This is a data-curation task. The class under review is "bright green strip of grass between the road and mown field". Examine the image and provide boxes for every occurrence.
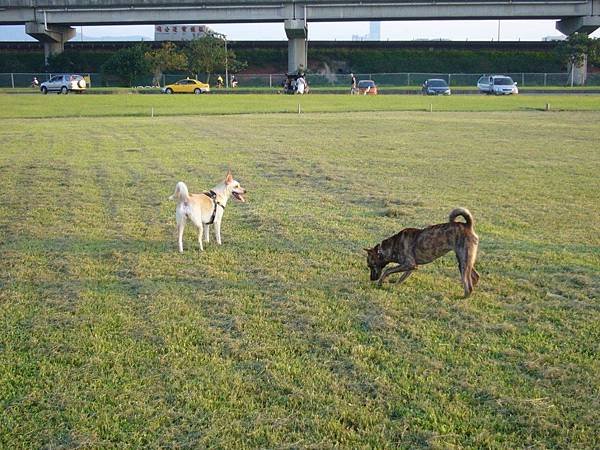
[0,94,600,118]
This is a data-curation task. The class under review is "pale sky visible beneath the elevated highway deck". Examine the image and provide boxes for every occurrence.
[0,20,600,41]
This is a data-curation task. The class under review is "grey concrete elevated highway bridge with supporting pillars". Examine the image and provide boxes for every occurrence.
[0,0,600,72]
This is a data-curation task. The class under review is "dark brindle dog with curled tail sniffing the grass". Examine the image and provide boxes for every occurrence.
[365,208,479,297]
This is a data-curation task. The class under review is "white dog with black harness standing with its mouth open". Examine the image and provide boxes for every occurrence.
[169,171,246,253]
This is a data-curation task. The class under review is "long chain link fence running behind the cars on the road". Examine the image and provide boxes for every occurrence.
[0,73,600,89]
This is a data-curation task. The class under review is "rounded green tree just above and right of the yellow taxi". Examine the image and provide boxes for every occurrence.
[187,35,247,83]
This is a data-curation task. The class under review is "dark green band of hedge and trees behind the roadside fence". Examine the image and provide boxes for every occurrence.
[0,33,600,81]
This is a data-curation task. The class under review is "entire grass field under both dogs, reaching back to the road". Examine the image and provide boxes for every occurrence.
[0,96,600,449]
